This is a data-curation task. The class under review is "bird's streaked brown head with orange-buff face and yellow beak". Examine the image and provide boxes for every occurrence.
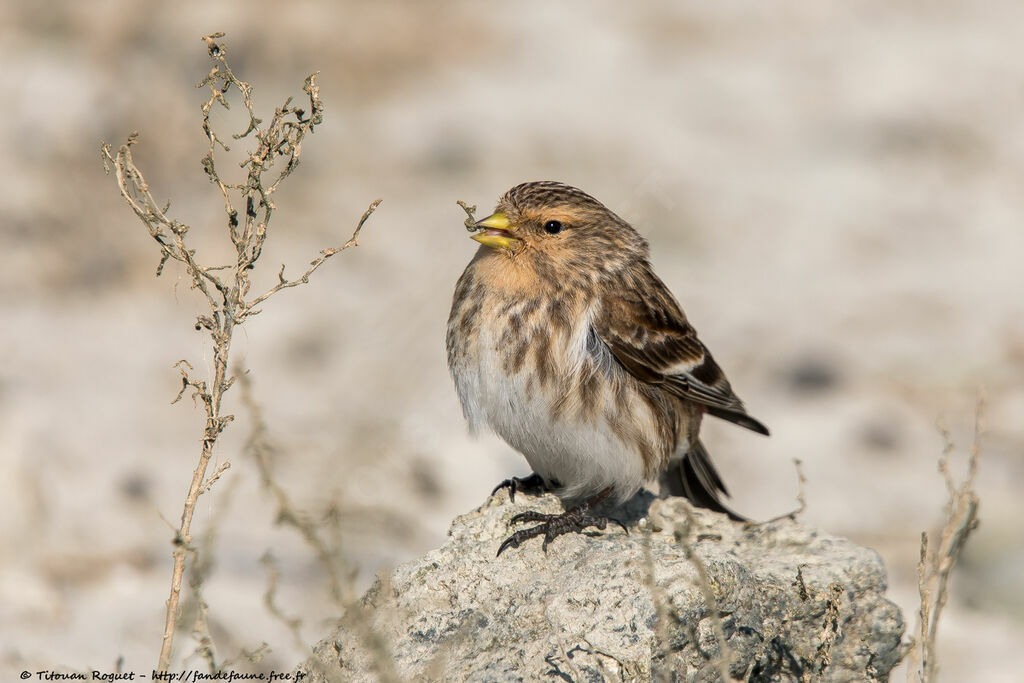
[470,181,647,279]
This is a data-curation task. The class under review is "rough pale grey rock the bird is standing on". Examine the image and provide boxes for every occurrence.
[302,493,904,681]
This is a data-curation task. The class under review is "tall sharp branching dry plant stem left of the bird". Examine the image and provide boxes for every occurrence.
[100,33,380,671]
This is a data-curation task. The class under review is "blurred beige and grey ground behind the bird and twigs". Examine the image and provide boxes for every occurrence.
[0,0,1024,681]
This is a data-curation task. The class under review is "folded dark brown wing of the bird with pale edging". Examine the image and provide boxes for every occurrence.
[594,268,768,434]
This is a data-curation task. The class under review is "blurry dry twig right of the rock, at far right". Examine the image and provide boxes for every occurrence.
[907,391,985,683]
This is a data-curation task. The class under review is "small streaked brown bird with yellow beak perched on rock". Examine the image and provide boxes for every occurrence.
[446,181,768,554]
